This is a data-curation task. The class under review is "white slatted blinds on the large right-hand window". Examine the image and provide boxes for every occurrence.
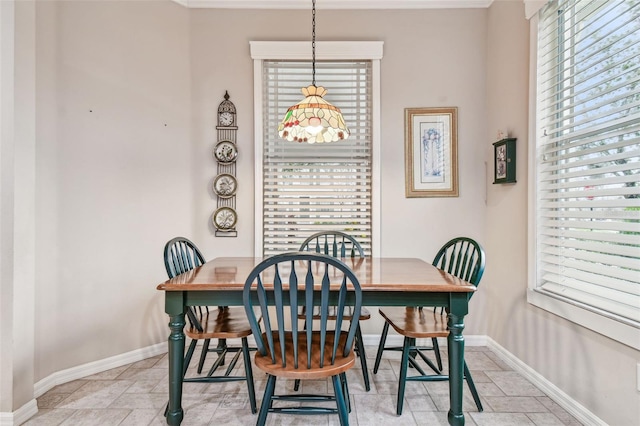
[536,0,640,327]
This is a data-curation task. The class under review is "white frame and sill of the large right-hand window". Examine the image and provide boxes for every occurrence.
[527,9,640,350]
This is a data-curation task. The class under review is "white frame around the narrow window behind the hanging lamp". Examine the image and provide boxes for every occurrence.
[249,41,383,257]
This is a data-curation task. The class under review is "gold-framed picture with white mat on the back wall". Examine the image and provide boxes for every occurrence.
[404,107,458,198]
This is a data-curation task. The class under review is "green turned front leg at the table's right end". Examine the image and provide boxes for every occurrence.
[447,294,468,426]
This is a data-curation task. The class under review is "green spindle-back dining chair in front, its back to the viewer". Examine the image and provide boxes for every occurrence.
[243,252,362,426]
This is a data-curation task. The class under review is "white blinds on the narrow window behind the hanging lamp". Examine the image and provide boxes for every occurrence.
[262,60,372,255]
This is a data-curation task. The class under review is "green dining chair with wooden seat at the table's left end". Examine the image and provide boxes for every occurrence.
[164,237,257,413]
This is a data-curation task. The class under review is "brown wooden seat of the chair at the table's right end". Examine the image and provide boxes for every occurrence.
[378,307,449,339]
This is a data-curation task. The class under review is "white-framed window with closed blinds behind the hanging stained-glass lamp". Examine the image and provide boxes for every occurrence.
[251,42,382,256]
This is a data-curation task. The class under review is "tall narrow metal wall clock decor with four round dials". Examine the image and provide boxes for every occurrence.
[211,91,238,237]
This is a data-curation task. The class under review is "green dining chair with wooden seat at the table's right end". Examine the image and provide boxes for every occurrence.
[373,237,485,415]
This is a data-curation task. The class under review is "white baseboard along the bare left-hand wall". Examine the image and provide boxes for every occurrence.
[33,343,167,398]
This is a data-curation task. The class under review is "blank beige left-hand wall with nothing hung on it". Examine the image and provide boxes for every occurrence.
[35,1,193,380]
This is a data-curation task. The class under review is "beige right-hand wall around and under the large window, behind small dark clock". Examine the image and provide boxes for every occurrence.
[483,1,640,426]
